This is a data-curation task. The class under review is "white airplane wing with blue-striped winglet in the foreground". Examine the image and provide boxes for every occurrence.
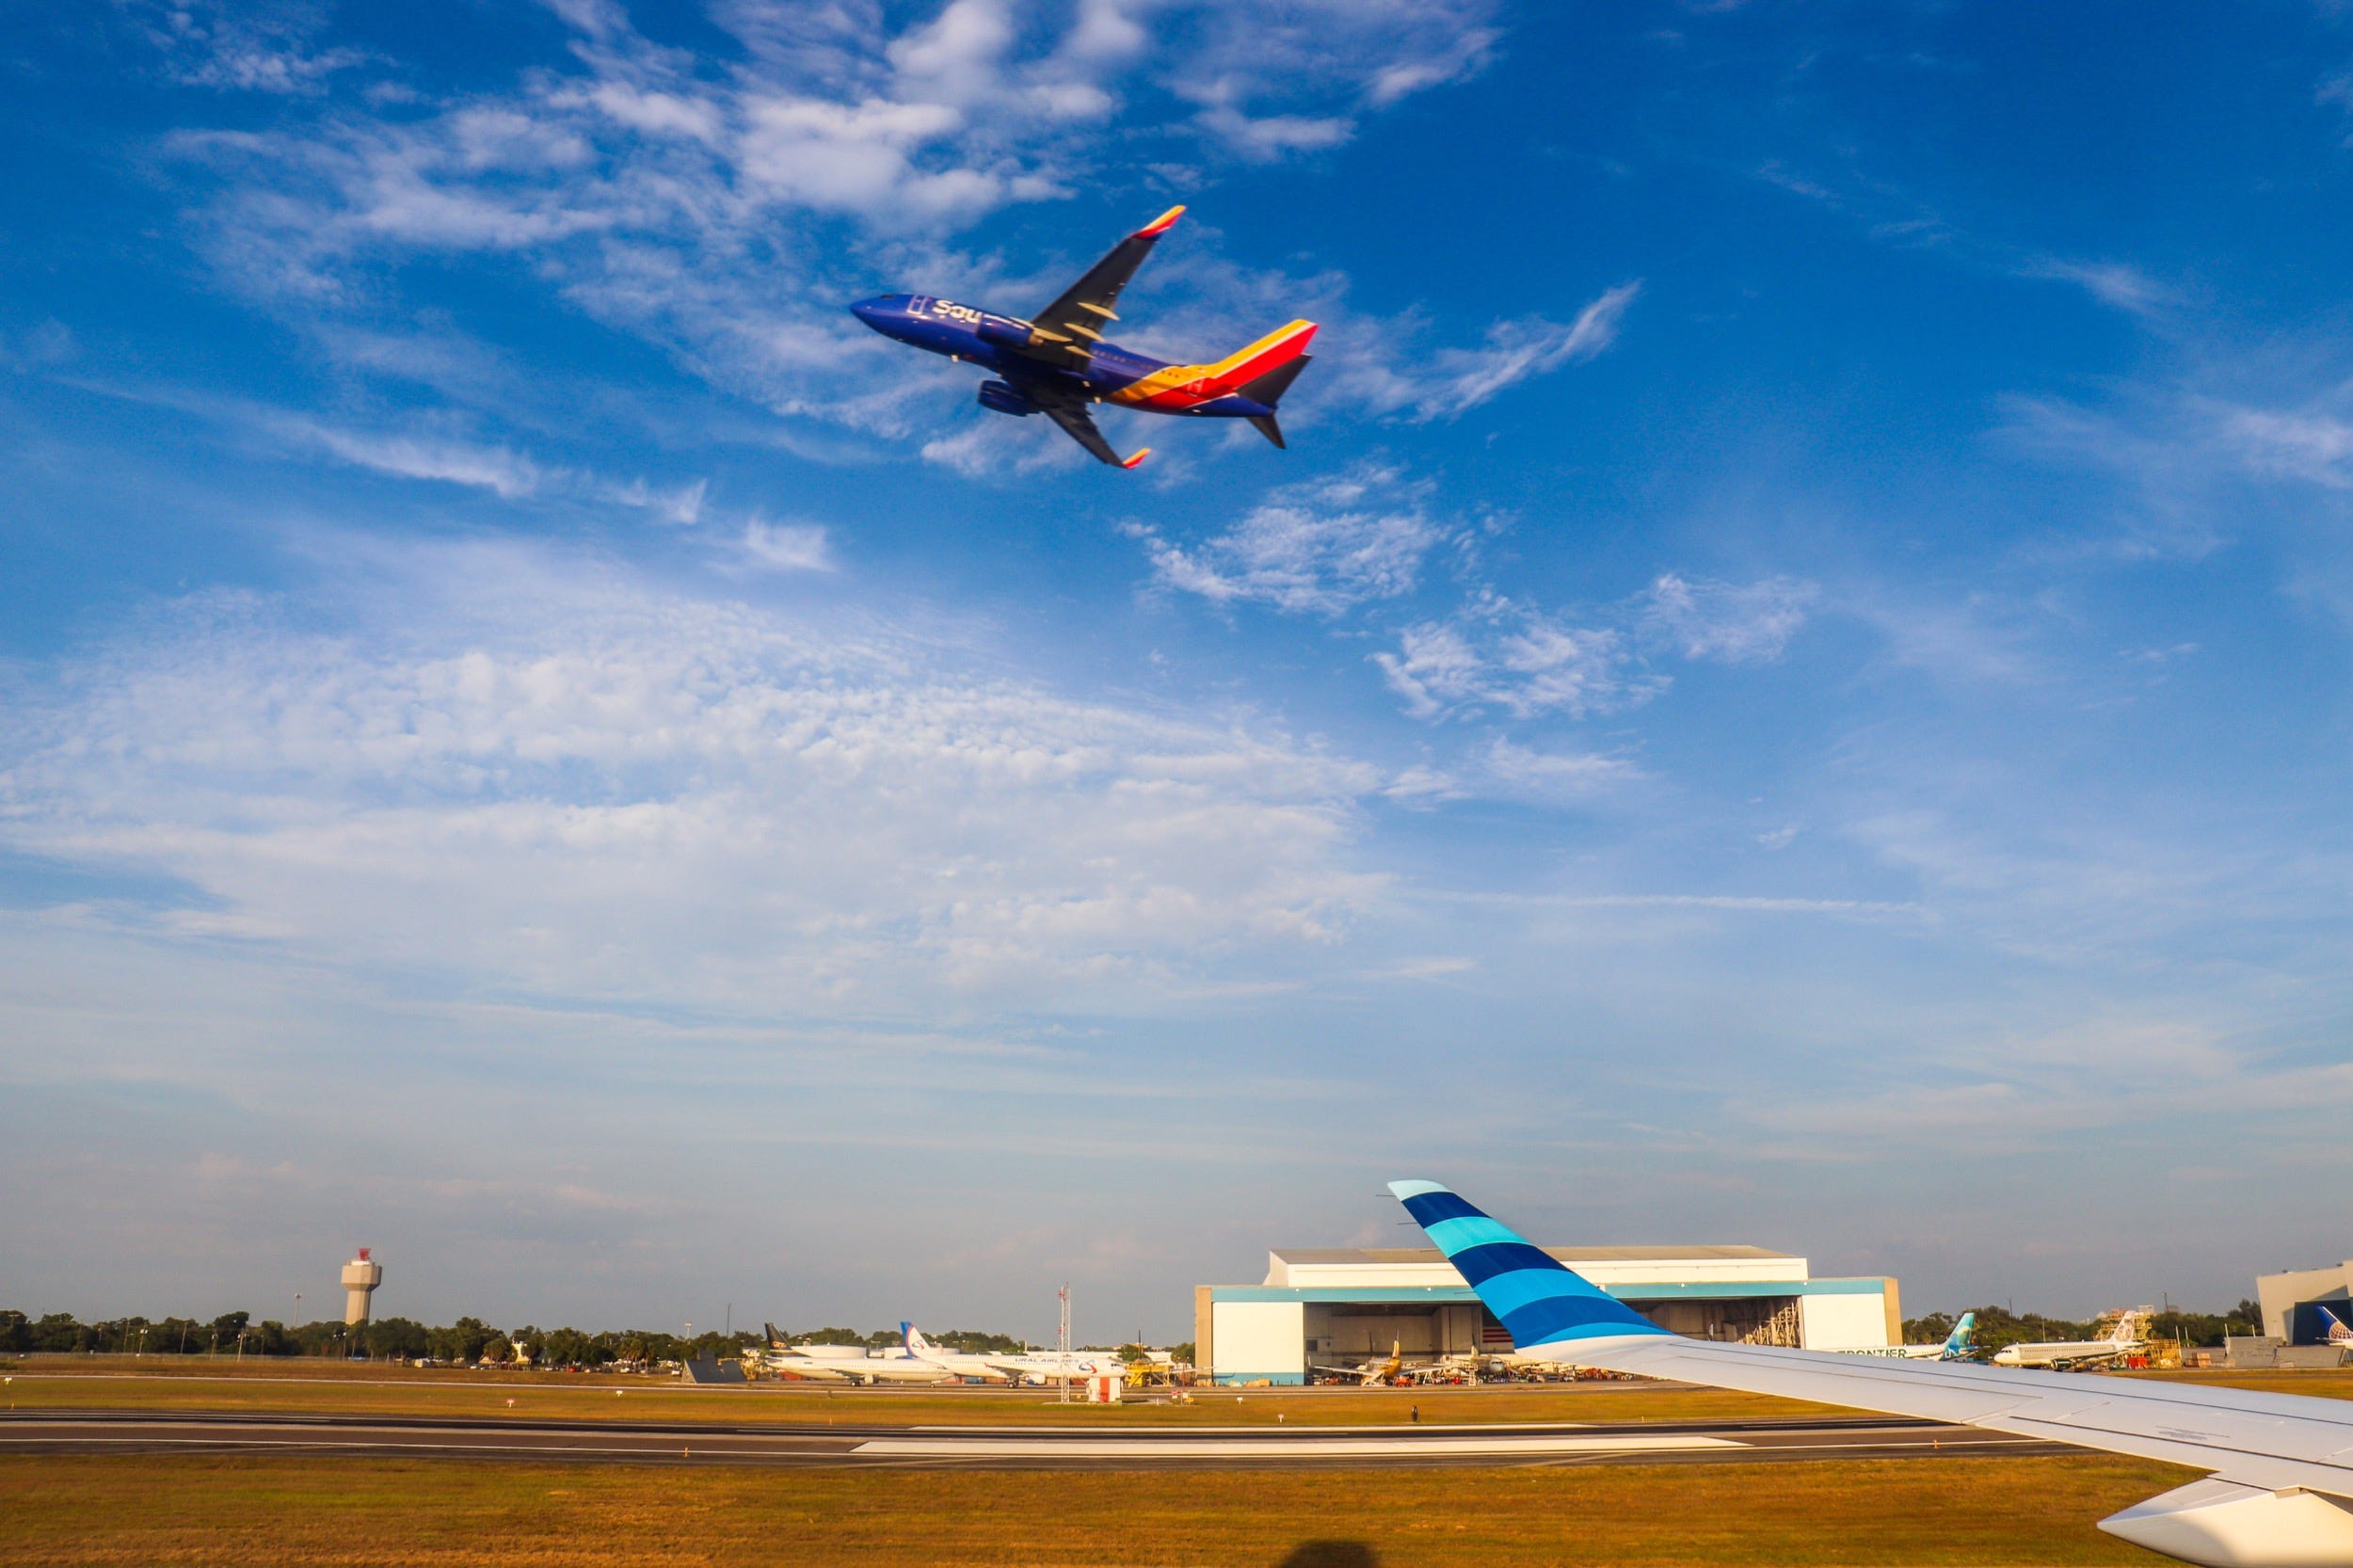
[1388,1182,2353,1568]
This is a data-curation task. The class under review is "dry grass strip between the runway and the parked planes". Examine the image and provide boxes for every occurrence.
[8,1358,1835,1427]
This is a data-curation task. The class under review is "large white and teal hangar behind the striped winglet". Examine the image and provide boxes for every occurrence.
[1193,1245,1904,1384]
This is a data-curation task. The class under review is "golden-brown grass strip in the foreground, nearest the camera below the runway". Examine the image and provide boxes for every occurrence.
[0,1455,2191,1568]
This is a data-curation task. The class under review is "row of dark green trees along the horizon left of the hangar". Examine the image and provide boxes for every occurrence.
[0,1311,1049,1366]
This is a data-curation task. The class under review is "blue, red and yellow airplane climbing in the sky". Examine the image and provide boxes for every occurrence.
[850,207,1316,469]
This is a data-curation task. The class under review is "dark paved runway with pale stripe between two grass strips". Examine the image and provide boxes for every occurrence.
[0,1410,2071,1469]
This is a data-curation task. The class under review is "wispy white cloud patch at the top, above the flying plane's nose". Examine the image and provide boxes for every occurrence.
[156,0,1506,452]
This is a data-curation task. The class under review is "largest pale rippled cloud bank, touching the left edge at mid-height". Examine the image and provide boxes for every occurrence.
[0,530,1384,1015]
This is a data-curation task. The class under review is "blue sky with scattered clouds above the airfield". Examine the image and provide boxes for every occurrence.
[0,0,2353,1337]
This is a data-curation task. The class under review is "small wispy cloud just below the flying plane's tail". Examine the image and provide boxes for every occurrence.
[1134,464,1445,615]
